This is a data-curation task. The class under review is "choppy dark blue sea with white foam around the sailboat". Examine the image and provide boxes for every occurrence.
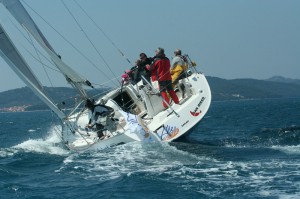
[0,99,300,199]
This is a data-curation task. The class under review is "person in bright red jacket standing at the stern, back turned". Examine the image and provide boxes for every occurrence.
[150,48,179,108]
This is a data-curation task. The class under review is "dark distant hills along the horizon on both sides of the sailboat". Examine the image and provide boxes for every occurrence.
[0,76,300,111]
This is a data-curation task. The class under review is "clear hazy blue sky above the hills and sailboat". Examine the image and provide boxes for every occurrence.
[0,0,300,92]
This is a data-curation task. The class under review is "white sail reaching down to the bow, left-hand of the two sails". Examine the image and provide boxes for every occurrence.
[0,24,65,119]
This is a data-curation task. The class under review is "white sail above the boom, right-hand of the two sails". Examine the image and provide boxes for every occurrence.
[0,0,89,96]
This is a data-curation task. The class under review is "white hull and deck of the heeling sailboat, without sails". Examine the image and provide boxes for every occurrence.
[63,73,211,151]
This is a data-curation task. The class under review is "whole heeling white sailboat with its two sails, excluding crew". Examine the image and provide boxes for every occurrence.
[0,0,211,151]
